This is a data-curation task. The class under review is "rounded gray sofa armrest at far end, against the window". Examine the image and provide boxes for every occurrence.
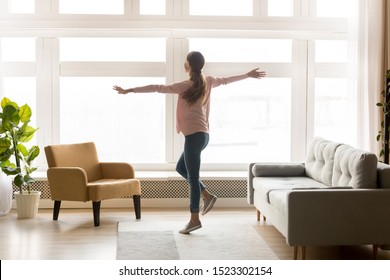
[251,162,305,177]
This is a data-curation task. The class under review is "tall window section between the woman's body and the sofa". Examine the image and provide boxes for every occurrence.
[190,38,292,163]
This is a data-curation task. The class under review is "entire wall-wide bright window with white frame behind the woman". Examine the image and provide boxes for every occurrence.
[0,0,358,170]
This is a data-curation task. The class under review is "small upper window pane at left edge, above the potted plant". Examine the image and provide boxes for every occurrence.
[0,38,36,61]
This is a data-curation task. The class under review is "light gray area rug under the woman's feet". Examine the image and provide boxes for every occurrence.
[117,221,278,260]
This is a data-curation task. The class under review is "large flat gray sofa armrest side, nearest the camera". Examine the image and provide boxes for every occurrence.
[286,189,390,246]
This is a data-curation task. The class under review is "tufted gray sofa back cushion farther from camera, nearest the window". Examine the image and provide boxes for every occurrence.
[305,137,341,186]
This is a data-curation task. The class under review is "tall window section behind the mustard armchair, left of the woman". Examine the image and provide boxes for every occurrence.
[59,38,166,163]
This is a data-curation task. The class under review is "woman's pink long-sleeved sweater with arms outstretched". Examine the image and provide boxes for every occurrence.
[133,74,248,136]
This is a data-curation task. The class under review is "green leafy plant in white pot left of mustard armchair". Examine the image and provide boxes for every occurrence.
[0,97,41,218]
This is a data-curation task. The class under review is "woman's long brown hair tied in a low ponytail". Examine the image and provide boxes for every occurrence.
[183,51,206,105]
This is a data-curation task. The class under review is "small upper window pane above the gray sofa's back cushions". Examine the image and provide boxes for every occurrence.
[315,40,348,63]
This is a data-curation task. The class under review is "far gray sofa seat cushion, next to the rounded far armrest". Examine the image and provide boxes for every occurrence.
[253,177,328,203]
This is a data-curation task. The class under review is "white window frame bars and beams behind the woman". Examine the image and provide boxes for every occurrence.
[0,0,354,170]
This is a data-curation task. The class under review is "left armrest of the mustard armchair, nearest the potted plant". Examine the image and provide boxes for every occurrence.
[47,167,89,201]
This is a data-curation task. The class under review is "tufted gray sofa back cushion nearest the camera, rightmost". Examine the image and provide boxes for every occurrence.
[332,145,378,189]
